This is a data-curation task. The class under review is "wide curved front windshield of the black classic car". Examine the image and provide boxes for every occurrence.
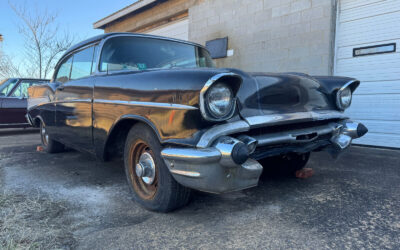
[100,36,214,72]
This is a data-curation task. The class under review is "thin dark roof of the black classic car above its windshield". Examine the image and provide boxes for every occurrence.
[61,32,208,58]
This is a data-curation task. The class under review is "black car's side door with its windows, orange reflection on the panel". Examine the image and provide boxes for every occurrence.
[55,46,95,152]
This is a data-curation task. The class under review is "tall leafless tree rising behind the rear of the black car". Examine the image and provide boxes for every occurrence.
[8,1,74,78]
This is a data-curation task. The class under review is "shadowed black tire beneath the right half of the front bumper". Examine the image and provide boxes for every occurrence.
[260,153,310,178]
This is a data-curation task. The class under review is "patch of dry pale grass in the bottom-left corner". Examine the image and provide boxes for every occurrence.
[0,192,76,249]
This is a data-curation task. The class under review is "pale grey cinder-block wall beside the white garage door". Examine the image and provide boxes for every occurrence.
[189,0,335,74]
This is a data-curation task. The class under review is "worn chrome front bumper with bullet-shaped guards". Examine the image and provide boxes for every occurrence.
[161,120,368,193]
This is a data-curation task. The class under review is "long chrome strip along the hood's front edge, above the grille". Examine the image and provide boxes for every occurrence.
[244,111,348,128]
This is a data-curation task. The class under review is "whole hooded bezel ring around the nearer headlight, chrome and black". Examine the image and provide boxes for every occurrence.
[199,73,242,122]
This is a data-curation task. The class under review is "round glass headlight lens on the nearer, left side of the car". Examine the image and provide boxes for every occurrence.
[207,83,234,118]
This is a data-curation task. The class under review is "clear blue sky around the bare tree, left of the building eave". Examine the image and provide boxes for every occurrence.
[0,0,135,72]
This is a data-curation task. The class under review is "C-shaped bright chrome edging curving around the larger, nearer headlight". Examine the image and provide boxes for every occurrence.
[200,72,241,121]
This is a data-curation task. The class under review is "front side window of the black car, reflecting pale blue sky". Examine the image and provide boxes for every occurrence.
[70,46,94,80]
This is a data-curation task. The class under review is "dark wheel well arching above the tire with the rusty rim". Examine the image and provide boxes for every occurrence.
[104,119,159,160]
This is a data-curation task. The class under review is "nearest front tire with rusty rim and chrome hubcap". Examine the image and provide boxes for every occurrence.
[124,124,191,212]
